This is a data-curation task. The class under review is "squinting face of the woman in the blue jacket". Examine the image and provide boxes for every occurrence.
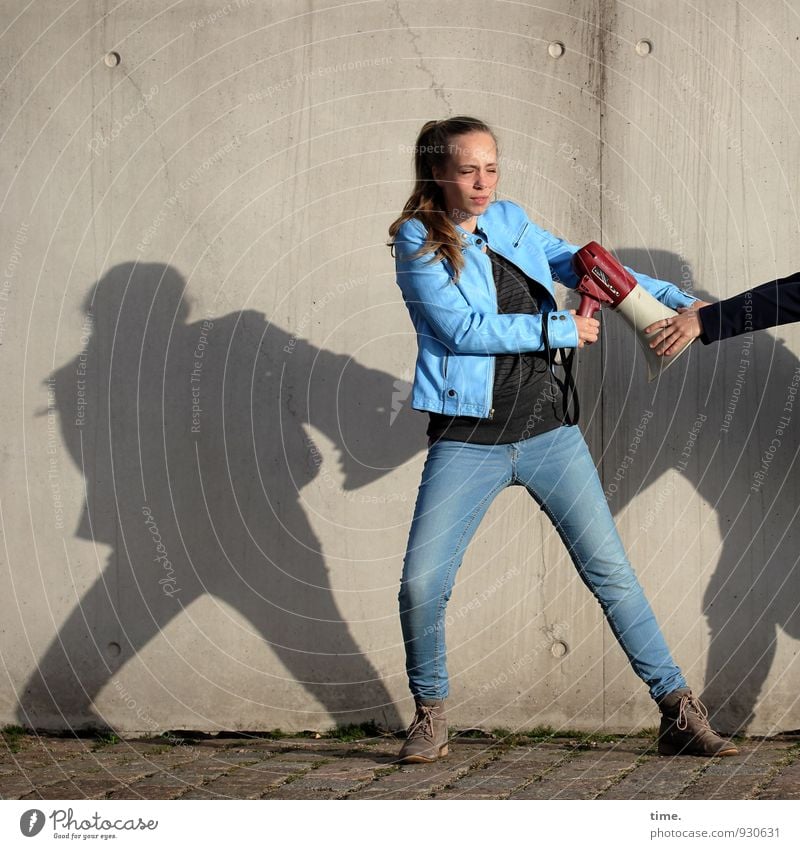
[433,131,498,230]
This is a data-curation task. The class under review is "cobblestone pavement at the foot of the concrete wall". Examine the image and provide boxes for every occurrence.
[0,734,800,800]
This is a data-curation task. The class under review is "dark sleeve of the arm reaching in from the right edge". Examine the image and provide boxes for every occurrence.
[699,271,800,345]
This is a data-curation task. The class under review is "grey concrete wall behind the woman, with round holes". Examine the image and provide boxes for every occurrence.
[0,0,800,733]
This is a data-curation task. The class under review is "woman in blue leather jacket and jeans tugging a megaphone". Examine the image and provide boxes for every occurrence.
[389,117,737,763]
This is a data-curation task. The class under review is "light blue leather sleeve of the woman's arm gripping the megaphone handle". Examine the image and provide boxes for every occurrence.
[394,222,578,354]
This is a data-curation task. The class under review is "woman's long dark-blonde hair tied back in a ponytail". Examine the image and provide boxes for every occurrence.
[387,115,497,280]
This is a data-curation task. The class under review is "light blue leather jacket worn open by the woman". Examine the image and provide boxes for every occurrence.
[394,200,695,418]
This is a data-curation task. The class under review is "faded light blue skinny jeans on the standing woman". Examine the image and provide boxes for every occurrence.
[399,426,686,701]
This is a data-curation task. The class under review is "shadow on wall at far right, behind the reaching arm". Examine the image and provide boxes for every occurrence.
[604,250,800,732]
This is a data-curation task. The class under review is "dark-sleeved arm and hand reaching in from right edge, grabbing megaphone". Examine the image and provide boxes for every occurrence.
[645,271,800,356]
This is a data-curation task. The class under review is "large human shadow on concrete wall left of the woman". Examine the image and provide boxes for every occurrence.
[19,263,424,729]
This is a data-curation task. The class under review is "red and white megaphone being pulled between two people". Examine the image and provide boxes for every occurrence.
[572,242,693,381]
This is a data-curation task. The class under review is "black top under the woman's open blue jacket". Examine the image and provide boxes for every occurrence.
[428,246,563,445]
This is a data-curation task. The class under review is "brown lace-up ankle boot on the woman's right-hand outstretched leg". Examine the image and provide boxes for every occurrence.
[658,687,739,757]
